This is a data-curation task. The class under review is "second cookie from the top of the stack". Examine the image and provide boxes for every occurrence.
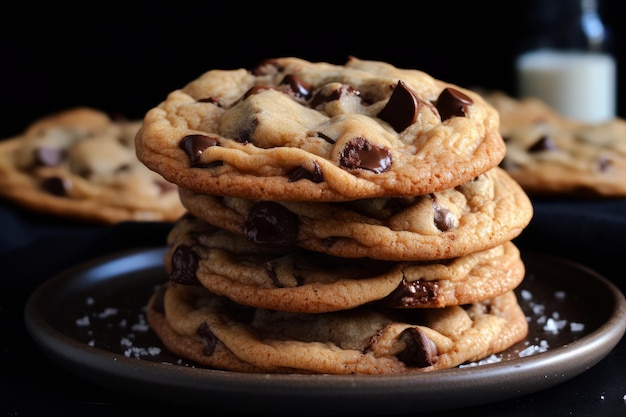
[179,167,533,260]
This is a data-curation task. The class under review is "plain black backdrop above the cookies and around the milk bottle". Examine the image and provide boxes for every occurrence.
[0,0,626,138]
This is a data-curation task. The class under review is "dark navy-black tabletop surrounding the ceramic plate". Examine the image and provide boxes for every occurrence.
[0,199,626,417]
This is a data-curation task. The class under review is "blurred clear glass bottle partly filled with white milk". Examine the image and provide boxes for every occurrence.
[515,0,617,123]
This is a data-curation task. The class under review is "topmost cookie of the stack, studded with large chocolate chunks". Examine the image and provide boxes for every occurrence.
[136,57,506,201]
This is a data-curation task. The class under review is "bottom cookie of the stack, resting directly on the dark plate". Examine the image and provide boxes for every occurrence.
[147,282,528,374]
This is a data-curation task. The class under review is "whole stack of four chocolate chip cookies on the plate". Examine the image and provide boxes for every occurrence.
[136,57,533,374]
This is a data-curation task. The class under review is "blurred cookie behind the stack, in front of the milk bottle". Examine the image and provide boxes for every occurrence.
[484,92,626,197]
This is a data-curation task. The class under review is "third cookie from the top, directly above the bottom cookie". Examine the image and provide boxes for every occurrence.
[165,215,525,313]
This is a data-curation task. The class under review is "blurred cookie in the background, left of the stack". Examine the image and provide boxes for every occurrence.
[0,107,185,224]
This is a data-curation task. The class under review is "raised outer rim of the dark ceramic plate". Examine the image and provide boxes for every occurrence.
[24,247,626,415]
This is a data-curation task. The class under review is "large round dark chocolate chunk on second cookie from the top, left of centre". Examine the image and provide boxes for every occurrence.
[244,201,298,246]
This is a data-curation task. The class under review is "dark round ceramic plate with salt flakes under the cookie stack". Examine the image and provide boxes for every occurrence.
[25,248,626,415]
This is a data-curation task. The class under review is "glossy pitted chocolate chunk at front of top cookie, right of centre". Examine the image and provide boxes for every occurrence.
[339,137,393,174]
